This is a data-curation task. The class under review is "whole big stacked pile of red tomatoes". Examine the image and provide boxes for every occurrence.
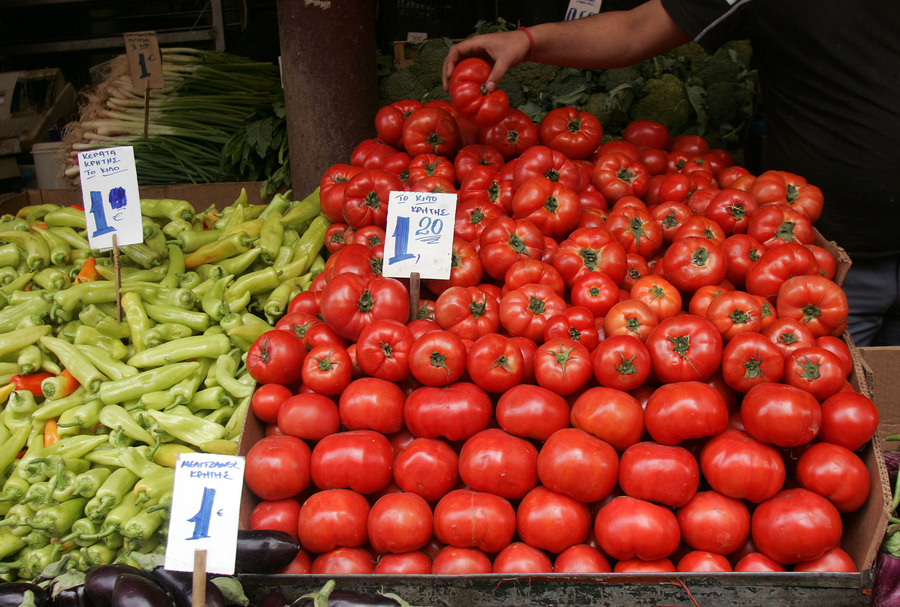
[239,60,878,574]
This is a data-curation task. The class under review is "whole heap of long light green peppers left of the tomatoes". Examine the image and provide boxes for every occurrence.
[0,192,330,581]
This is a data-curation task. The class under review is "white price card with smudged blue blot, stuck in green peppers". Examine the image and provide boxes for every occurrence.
[78,146,144,251]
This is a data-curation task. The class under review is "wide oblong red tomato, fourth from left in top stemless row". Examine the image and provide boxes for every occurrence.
[403,382,493,441]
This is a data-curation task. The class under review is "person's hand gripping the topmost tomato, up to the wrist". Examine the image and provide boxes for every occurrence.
[441,30,531,92]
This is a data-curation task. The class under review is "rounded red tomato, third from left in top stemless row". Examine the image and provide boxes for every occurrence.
[335,377,406,435]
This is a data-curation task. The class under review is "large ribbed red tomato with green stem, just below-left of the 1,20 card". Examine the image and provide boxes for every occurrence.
[321,276,409,340]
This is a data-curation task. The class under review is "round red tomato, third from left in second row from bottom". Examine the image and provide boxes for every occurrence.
[367,493,432,554]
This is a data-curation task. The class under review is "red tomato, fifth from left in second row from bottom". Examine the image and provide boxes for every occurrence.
[516,485,591,554]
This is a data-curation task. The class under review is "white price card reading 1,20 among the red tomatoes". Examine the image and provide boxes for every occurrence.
[382,192,456,280]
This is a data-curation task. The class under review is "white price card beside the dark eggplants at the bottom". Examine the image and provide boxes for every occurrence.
[165,453,244,575]
